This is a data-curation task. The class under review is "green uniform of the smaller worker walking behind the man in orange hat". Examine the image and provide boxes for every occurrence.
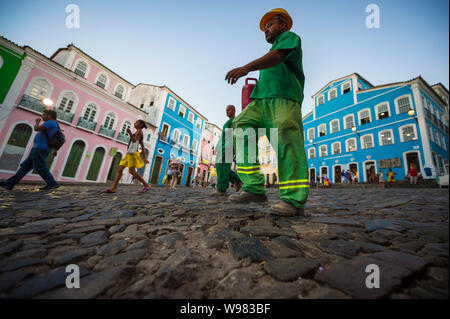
[216,119,238,192]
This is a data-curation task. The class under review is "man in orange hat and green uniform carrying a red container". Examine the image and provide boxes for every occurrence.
[225,9,309,216]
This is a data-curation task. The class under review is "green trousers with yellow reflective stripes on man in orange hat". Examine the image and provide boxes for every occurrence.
[232,98,309,207]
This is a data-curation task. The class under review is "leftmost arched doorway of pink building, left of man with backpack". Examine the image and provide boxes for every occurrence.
[0,124,33,171]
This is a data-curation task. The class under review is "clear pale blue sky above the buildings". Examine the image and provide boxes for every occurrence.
[0,0,449,127]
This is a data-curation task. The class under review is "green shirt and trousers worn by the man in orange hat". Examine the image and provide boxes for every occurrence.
[232,31,309,208]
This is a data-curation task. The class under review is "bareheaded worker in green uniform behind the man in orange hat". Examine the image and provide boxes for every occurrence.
[213,105,242,195]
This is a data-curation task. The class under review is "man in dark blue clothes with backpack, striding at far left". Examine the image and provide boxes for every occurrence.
[0,110,59,190]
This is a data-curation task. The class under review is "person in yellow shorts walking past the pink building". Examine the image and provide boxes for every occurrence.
[105,120,150,193]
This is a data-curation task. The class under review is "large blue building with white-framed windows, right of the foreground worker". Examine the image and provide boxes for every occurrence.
[303,73,449,183]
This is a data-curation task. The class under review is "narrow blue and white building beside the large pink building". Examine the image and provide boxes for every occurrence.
[149,87,207,185]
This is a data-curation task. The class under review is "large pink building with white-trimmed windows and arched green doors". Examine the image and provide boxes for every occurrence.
[0,38,156,182]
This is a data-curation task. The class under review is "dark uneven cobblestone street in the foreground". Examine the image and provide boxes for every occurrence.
[0,185,449,298]
